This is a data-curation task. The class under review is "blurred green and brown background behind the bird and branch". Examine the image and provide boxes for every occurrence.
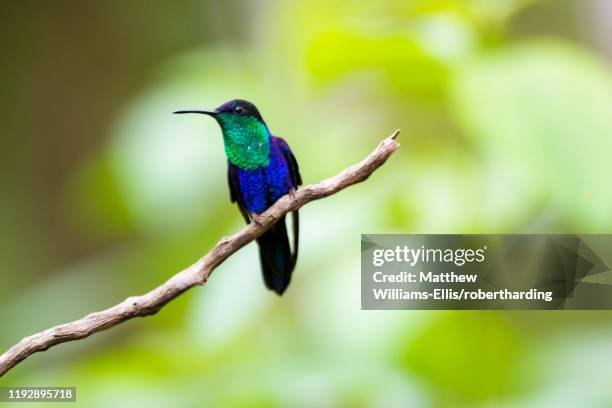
[0,0,612,407]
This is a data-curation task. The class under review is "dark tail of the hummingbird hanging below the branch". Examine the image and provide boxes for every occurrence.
[257,212,297,295]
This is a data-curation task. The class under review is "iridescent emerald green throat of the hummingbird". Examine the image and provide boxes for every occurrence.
[217,113,270,170]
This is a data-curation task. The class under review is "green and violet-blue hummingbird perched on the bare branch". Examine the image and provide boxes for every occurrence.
[174,99,302,295]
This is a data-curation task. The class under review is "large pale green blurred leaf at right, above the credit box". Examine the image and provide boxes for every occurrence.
[452,41,612,230]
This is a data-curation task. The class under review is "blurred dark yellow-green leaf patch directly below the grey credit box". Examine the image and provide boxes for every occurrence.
[402,312,519,401]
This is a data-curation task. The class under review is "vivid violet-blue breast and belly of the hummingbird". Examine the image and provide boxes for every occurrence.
[238,143,293,214]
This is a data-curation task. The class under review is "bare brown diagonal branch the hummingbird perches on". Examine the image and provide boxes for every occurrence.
[0,130,399,377]
